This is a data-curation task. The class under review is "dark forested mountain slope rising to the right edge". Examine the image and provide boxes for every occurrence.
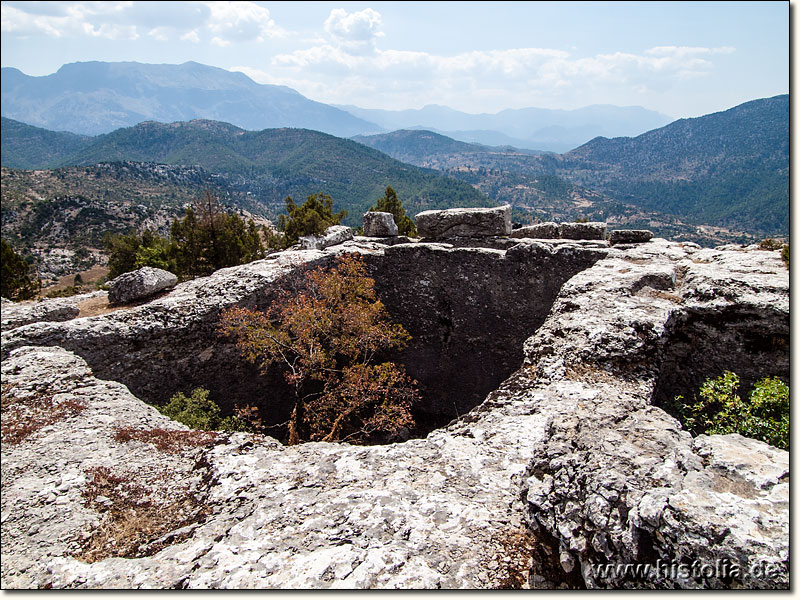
[543,95,789,235]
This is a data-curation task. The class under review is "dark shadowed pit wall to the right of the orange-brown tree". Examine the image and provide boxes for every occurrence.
[369,242,604,424]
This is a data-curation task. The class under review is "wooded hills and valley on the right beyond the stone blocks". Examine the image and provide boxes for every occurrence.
[355,95,789,241]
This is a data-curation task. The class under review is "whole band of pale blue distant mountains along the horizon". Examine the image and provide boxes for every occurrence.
[1,62,672,152]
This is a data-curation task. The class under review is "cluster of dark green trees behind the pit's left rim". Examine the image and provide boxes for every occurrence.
[106,192,266,279]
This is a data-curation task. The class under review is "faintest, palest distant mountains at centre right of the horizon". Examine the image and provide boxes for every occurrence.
[339,104,672,152]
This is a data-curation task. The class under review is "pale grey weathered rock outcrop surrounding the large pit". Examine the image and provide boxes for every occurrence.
[0,240,789,589]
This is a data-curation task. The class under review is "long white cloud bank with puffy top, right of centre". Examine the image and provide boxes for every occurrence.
[260,29,734,110]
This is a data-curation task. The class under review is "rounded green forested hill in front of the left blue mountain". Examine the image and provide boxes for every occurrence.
[2,120,493,225]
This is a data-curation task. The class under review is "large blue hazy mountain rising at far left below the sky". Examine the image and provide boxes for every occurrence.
[0,62,380,136]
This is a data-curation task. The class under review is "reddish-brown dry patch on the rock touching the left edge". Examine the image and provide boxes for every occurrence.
[0,386,87,445]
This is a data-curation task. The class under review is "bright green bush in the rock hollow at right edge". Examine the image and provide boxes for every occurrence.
[675,371,789,450]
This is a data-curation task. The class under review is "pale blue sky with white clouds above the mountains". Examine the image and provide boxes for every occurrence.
[0,0,795,118]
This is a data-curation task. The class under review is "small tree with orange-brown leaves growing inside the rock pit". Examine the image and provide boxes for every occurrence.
[219,256,418,444]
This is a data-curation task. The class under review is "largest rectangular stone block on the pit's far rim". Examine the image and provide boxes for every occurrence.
[414,205,511,240]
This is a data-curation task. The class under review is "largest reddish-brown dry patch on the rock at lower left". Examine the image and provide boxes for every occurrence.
[74,467,208,563]
